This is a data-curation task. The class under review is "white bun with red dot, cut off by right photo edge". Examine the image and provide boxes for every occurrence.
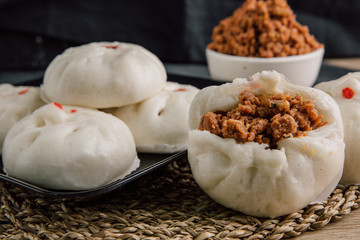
[315,72,360,184]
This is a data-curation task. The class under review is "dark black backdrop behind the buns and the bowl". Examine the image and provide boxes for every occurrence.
[0,0,360,71]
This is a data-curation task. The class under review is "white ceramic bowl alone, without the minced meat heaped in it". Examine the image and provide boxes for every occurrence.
[206,48,324,87]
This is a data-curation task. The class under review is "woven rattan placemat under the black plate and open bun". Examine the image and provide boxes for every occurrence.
[0,158,360,240]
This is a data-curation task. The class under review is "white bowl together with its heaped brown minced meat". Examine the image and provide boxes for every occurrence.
[206,0,324,86]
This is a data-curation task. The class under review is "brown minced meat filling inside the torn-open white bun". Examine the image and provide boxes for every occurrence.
[198,90,327,148]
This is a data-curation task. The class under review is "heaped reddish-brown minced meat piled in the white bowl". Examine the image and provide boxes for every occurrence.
[208,0,324,58]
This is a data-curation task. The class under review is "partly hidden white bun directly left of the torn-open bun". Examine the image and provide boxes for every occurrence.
[111,82,199,153]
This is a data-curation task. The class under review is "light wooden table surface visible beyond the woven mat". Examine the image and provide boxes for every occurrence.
[292,58,360,240]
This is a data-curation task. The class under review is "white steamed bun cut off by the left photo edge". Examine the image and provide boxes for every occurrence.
[0,83,45,153]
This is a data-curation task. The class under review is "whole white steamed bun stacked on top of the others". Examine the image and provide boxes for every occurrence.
[41,42,167,108]
